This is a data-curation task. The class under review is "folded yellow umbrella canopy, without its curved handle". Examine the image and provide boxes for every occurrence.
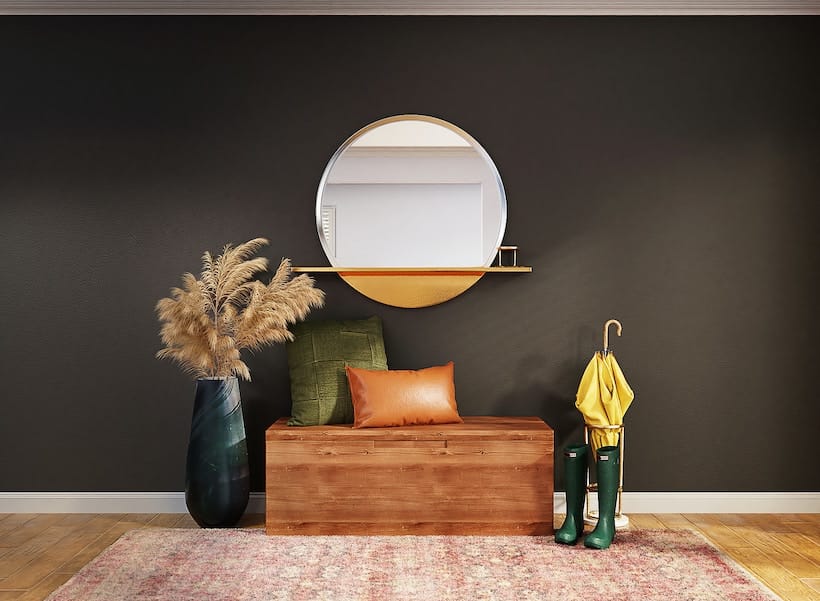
[575,351,635,453]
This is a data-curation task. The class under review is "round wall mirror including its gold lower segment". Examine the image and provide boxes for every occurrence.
[316,115,507,307]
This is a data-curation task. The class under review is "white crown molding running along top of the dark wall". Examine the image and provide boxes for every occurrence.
[0,0,820,16]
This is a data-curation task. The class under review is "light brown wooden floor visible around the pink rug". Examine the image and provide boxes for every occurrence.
[0,513,820,601]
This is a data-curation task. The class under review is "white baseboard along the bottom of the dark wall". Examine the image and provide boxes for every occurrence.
[0,492,820,514]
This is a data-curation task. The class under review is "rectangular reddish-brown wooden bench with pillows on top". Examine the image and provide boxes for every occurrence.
[265,417,554,535]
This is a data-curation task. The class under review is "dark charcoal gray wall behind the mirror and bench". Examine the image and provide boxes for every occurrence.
[0,17,820,491]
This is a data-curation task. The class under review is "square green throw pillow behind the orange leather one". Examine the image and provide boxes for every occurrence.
[286,317,387,426]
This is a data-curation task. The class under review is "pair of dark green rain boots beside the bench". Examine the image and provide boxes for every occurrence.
[555,444,621,549]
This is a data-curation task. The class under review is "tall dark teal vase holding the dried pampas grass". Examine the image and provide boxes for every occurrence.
[185,377,250,528]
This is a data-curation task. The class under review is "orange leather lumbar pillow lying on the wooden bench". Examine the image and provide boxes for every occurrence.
[345,361,463,428]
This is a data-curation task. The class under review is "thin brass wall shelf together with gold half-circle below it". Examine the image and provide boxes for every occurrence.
[293,266,532,309]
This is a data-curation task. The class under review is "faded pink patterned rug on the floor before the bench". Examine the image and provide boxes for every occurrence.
[48,528,779,601]
